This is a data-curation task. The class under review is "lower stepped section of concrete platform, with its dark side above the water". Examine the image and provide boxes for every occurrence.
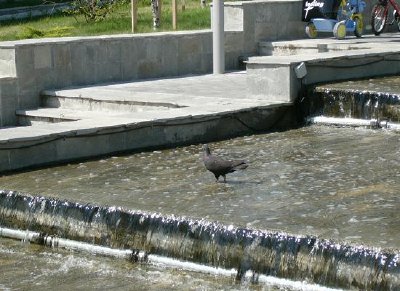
[0,71,293,172]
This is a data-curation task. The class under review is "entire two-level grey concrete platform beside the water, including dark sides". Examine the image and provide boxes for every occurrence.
[0,34,400,176]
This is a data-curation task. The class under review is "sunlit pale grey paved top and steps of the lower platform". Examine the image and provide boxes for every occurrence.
[0,71,286,144]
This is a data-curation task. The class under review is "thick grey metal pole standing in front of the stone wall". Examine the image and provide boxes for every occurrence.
[212,0,225,74]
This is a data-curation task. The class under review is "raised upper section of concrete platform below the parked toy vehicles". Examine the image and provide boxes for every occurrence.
[247,34,400,101]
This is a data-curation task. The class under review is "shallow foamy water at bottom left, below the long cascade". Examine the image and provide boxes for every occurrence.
[0,238,255,290]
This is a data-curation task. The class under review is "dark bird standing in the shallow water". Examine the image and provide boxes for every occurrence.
[203,144,248,182]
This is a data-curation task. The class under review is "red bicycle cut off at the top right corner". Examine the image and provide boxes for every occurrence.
[371,0,400,35]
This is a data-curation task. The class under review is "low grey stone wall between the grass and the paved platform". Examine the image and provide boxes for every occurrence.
[0,30,247,126]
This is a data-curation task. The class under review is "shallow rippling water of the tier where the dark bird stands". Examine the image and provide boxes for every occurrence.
[0,126,400,249]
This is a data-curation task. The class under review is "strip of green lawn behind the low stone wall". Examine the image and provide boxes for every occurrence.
[0,0,211,41]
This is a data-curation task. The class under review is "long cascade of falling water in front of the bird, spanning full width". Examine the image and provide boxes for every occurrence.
[0,190,400,290]
